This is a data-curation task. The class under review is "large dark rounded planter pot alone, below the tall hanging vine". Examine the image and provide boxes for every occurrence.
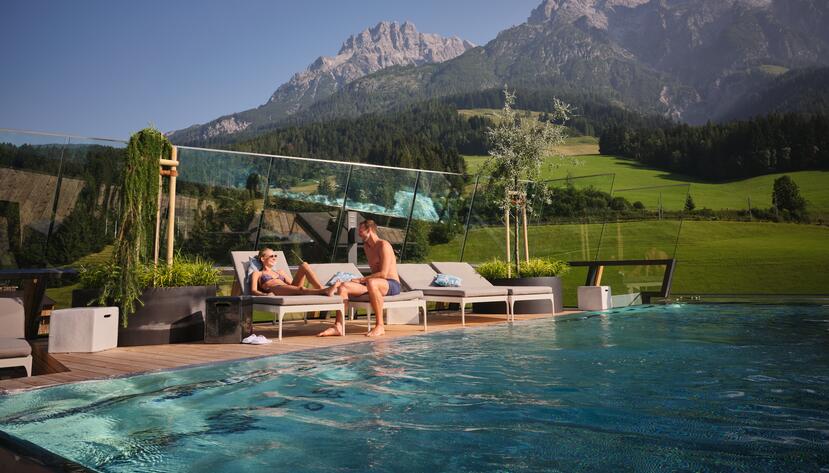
[72,286,216,347]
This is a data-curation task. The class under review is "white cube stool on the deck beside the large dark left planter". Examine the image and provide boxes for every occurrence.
[49,307,118,353]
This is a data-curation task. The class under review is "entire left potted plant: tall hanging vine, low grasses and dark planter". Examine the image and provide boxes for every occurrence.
[73,128,218,345]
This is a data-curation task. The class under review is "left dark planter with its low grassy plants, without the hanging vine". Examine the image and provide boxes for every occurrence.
[72,257,220,346]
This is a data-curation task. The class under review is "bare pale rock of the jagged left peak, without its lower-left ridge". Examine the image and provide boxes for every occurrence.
[269,21,475,113]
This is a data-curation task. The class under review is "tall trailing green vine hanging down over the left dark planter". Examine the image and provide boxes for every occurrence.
[99,128,173,327]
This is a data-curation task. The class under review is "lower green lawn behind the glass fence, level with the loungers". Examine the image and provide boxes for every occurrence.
[429,221,829,303]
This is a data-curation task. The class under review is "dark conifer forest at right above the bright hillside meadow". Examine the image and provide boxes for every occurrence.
[599,113,829,180]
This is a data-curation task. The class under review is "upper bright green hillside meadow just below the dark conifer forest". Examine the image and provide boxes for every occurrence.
[466,137,829,221]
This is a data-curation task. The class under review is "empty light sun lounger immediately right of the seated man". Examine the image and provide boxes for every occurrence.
[397,264,510,325]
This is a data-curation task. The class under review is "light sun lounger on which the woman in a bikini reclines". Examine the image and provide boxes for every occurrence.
[230,251,345,340]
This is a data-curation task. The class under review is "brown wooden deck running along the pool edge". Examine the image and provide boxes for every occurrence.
[0,311,572,393]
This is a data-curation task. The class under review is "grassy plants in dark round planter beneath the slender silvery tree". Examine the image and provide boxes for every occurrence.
[474,258,570,314]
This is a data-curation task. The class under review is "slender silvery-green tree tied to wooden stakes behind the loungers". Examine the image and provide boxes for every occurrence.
[483,87,572,275]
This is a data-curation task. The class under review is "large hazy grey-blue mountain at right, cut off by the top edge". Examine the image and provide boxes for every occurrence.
[296,0,829,123]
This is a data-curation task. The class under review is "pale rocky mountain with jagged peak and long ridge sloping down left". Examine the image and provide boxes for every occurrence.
[170,22,474,144]
